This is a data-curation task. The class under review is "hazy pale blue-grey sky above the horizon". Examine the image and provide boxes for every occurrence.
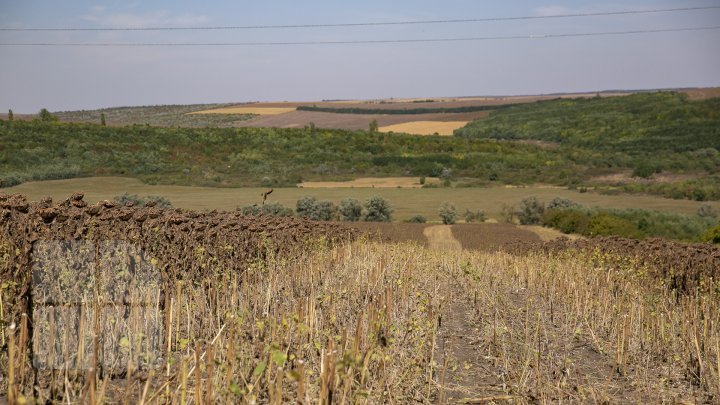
[0,0,720,113]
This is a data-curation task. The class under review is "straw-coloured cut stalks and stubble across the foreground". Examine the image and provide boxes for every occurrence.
[3,238,720,404]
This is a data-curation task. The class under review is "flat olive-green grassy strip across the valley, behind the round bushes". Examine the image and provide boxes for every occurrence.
[0,177,720,221]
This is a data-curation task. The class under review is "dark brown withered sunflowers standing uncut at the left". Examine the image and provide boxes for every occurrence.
[0,193,359,315]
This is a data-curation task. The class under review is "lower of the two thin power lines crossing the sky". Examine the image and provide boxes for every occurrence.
[0,25,720,47]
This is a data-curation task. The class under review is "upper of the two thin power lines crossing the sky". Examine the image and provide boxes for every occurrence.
[0,6,720,31]
